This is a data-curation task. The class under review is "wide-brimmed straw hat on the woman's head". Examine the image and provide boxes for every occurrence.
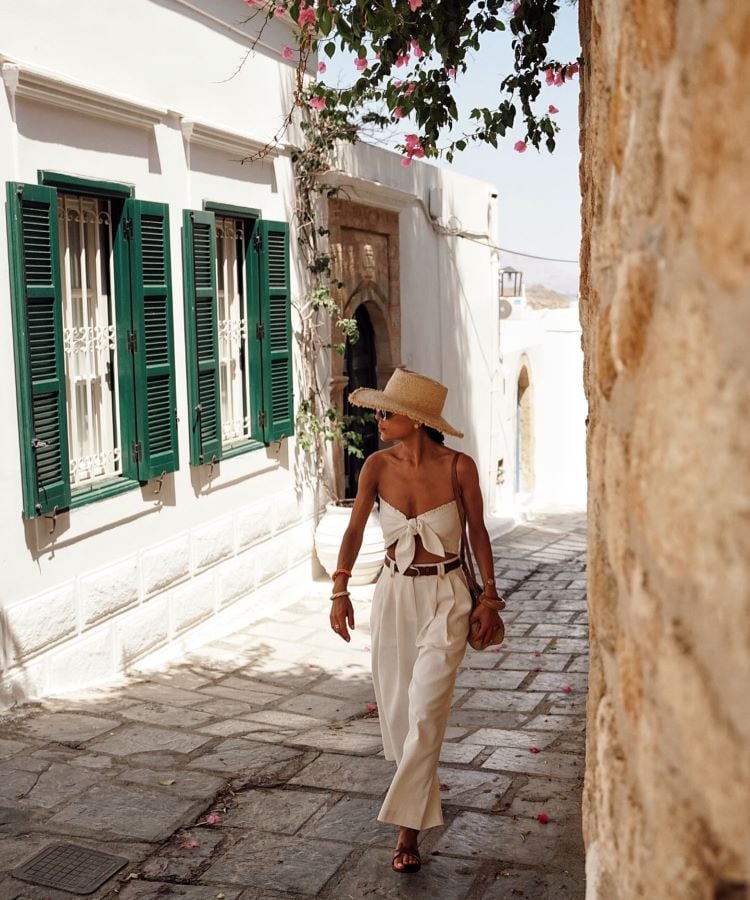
[349,367,464,437]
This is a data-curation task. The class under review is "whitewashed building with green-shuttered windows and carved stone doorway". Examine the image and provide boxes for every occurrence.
[0,0,516,704]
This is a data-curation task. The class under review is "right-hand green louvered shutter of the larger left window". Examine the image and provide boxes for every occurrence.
[125,200,178,481]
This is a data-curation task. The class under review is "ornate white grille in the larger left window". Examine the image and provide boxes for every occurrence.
[57,194,121,488]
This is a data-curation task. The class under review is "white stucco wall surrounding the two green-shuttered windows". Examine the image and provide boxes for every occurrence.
[0,0,312,703]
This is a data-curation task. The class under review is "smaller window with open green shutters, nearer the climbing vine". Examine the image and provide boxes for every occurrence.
[183,209,293,466]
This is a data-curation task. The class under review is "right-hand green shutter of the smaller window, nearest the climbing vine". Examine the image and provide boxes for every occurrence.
[259,220,294,442]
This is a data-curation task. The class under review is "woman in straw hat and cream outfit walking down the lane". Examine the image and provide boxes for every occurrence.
[331,369,504,872]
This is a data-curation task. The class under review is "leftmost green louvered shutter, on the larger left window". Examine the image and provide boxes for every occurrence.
[7,183,70,518]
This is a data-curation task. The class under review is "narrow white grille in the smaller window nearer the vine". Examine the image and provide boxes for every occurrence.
[216,216,250,448]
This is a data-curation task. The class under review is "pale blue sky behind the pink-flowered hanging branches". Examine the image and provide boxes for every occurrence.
[324,4,580,294]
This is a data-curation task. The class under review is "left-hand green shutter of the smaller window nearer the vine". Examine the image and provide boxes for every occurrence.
[182,209,221,466]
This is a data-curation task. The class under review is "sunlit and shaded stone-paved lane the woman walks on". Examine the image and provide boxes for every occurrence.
[0,513,588,900]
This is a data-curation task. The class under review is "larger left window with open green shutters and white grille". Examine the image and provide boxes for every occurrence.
[7,179,177,518]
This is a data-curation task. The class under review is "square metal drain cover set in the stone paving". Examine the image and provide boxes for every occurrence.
[11,844,128,894]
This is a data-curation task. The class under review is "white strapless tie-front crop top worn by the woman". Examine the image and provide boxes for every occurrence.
[380,497,461,572]
